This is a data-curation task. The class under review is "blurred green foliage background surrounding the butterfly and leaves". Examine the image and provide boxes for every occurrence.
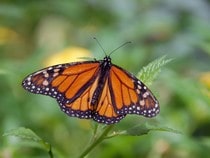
[0,0,210,158]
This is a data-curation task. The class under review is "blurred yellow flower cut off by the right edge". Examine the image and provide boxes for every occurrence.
[200,72,210,97]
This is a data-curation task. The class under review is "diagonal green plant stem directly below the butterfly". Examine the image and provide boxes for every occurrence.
[79,125,114,158]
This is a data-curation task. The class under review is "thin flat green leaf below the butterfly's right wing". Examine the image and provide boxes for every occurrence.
[121,124,181,136]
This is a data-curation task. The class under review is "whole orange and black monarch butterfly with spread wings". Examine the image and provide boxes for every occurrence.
[22,41,159,124]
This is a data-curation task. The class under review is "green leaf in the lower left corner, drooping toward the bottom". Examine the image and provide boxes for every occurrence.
[3,127,51,153]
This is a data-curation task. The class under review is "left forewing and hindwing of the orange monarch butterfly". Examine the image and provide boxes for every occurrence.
[22,61,99,118]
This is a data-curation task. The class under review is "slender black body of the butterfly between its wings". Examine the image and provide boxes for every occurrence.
[91,56,112,109]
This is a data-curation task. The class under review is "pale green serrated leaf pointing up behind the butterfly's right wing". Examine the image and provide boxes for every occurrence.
[137,55,172,85]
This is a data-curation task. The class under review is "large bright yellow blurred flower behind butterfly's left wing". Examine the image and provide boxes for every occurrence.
[45,47,92,66]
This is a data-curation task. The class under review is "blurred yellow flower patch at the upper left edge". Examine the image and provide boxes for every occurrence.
[0,27,18,44]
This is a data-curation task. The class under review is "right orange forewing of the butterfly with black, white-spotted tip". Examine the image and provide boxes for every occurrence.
[109,65,159,117]
